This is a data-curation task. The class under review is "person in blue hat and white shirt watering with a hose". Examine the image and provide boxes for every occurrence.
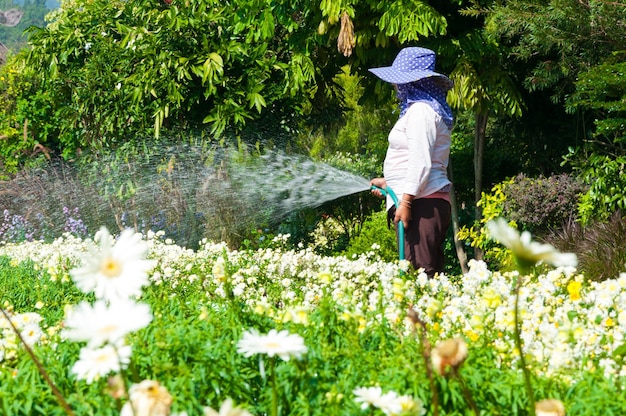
[370,47,454,277]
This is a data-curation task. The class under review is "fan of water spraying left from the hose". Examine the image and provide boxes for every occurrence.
[0,144,369,246]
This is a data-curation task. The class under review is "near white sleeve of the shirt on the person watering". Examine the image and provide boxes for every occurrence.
[404,102,437,196]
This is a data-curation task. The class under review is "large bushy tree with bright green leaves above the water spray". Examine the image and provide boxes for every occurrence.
[1,0,326,156]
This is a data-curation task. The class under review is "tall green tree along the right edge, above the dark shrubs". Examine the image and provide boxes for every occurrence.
[488,0,626,222]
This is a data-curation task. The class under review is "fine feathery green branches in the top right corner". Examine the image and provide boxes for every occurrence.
[487,0,626,101]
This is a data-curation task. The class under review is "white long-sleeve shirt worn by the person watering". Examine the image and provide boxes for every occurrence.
[383,102,451,209]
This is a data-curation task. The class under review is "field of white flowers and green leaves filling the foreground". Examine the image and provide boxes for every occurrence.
[0,229,626,416]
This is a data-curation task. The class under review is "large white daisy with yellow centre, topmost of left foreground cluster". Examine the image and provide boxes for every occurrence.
[70,227,156,300]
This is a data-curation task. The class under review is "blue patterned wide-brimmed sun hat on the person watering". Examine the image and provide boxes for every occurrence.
[370,47,454,90]
